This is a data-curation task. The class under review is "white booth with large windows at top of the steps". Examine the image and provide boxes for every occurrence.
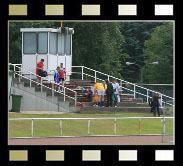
[20,27,74,81]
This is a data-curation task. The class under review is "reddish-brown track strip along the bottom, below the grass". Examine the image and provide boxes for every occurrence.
[8,136,173,145]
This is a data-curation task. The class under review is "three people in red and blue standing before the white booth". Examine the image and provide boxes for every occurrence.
[36,59,66,92]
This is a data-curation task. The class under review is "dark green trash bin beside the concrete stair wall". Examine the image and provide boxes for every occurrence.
[11,94,22,112]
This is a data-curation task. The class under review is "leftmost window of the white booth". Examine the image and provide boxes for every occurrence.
[23,32,37,54]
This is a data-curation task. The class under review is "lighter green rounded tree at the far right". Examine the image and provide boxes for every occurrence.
[143,22,173,84]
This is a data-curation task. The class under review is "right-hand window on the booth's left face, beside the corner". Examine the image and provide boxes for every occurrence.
[38,32,48,54]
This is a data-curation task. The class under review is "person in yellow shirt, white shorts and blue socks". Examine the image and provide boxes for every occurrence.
[94,82,105,107]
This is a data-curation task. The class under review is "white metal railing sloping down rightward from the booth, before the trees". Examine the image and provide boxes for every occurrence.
[72,66,174,106]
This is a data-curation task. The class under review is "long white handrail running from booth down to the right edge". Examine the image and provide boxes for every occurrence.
[72,66,174,106]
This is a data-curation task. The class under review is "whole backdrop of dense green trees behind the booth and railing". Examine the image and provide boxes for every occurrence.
[9,22,173,83]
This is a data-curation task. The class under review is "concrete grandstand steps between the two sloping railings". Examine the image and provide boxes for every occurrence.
[13,78,169,114]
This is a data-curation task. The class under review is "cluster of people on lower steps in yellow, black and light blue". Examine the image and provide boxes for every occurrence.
[93,80,119,107]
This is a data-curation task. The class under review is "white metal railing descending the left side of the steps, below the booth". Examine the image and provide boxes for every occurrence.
[10,64,77,106]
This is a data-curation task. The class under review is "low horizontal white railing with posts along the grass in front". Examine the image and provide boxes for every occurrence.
[9,117,174,142]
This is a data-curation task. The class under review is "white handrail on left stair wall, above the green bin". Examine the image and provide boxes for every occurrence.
[9,64,77,106]
